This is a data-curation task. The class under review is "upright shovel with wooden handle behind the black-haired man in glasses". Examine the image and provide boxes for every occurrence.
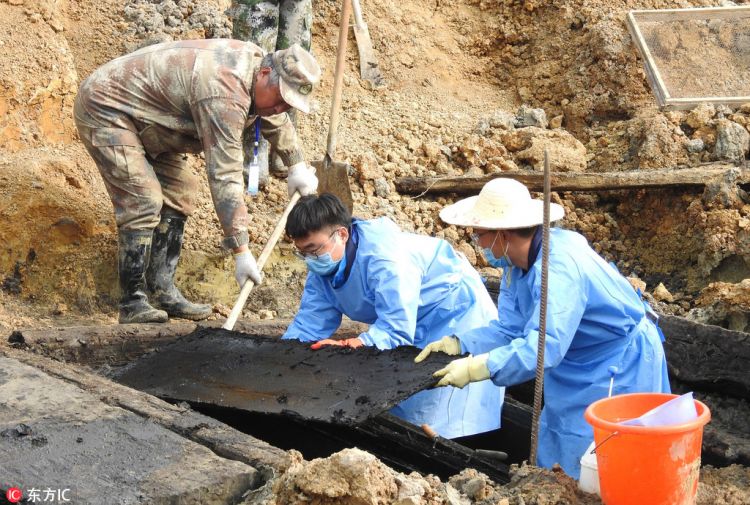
[312,0,354,213]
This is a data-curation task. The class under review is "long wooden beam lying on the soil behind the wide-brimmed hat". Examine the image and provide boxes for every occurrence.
[396,163,750,195]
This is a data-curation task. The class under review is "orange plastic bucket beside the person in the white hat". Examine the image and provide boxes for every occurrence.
[584,393,711,505]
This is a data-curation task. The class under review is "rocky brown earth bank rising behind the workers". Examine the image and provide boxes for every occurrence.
[0,0,750,503]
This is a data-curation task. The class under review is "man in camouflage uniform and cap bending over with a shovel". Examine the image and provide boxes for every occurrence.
[74,39,320,323]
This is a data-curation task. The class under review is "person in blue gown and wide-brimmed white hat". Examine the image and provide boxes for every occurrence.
[417,179,670,478]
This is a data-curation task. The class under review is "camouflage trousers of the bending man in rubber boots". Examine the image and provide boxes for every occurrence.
[74,99,199,231]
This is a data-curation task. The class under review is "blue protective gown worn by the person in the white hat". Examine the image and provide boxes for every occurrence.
[458,229,670,479]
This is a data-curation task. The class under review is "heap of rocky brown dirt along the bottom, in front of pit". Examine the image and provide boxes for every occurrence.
[246,449,750,505]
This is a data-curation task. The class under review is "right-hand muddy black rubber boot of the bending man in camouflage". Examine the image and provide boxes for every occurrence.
[146,207,212,321]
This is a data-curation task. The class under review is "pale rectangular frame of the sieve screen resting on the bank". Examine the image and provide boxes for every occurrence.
[627,6,750,110]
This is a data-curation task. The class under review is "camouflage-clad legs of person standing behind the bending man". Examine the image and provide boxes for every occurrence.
[227,0,312,183]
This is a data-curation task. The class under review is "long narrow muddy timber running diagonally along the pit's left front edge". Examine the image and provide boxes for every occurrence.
[0,349,290,474]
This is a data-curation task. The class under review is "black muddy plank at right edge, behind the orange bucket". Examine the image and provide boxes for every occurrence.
[659,315,750,399]
